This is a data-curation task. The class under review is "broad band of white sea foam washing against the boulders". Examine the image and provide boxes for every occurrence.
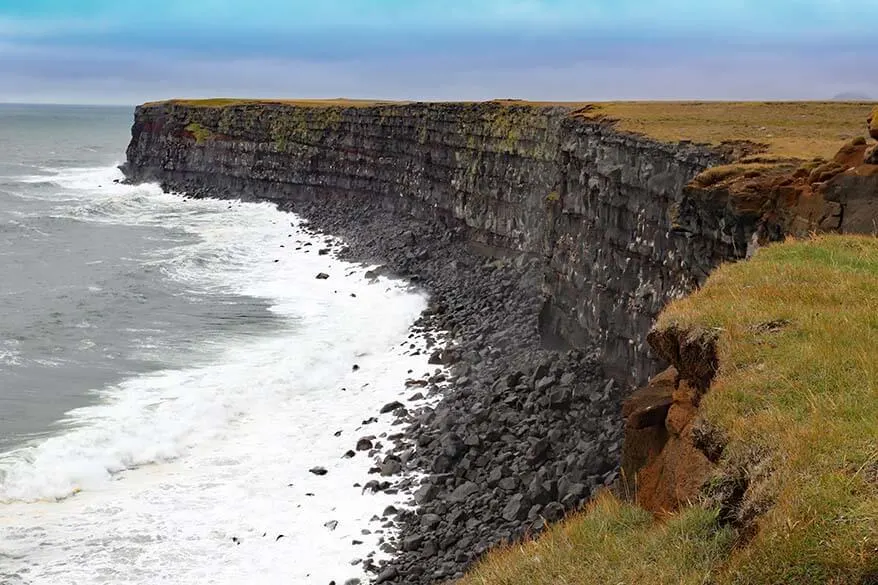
[0,169,440,585]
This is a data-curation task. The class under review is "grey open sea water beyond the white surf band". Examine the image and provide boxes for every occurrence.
[0,105,278,453]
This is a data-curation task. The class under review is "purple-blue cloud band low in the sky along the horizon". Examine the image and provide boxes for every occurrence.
[0,34,878,104]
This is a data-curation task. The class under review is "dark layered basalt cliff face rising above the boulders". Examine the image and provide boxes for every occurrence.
[124,102,762,384]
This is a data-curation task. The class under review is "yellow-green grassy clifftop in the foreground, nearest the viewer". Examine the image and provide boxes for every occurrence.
[462,236,878,585]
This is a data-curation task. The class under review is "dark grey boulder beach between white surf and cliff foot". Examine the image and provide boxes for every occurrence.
[174,185,623,584]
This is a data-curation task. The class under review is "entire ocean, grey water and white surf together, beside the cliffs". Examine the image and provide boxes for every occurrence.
[0,105,430,585]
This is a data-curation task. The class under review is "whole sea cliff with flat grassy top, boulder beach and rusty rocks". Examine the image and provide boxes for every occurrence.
[124,100,878,583]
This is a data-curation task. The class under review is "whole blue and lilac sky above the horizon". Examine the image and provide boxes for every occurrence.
[0,0,878,104]
